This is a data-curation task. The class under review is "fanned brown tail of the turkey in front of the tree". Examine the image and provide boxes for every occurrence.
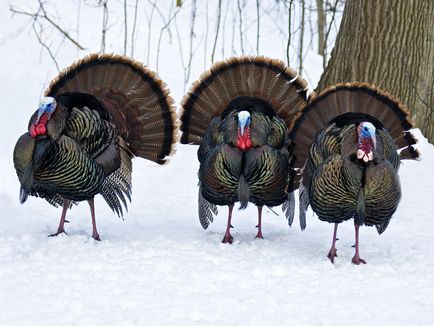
[289,82,419,169]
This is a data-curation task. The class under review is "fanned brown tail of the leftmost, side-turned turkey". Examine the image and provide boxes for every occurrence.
[45,53,178,164]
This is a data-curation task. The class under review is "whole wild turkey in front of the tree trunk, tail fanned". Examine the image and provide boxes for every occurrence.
[290,83,419,265]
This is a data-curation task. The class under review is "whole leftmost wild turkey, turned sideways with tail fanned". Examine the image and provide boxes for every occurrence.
[14,54,177,240]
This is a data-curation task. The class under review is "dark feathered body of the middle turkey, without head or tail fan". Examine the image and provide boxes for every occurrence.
[198,99,290,208]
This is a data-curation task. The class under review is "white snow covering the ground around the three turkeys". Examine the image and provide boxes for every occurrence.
[0,2,434,325]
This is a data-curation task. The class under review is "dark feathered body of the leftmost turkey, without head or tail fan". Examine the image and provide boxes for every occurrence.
[14,93,121,204]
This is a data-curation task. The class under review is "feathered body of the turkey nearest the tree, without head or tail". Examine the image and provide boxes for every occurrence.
[302,119,401,229]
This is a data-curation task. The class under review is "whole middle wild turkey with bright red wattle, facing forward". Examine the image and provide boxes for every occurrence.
[181,57,307,243]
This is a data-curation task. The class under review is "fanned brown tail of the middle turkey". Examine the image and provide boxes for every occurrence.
[181,56,307,144]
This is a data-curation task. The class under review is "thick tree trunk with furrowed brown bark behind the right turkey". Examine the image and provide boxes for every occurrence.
[317,0,434,143]
